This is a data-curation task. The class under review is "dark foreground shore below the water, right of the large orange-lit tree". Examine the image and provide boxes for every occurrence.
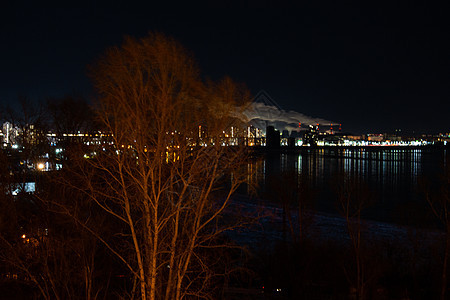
[223,198,450,299]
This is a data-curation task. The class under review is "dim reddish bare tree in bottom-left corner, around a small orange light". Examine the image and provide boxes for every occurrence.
[0,155,103,299]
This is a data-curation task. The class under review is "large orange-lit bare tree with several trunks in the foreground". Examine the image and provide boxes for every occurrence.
[62,33,250,300]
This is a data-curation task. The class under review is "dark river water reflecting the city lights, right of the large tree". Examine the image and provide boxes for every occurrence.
[248,147,450,227]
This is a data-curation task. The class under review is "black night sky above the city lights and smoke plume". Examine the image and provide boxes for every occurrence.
[0,1,450,133]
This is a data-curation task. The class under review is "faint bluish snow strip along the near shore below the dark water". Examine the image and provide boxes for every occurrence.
[225,196,443,247]
